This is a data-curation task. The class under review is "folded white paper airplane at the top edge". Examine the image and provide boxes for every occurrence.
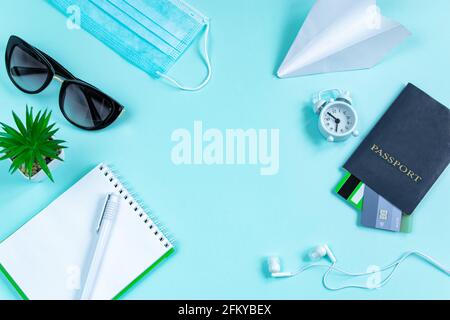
[277,0,411,78]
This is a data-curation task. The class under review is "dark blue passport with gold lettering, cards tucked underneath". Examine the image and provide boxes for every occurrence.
[344,84,450,214]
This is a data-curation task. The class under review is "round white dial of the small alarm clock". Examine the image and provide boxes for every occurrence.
[320,102,358,137]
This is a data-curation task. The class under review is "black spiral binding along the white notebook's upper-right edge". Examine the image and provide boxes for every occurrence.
[98,164,175,248]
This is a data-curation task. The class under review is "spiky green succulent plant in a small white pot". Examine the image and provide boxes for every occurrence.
[0,106,66,181]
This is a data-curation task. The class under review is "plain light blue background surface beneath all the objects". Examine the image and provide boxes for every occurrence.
[0,0,450,299]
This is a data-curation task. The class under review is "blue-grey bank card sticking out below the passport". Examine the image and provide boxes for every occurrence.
[361,186,402,232]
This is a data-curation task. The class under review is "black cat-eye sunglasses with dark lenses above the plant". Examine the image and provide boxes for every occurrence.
[5,36,124,130]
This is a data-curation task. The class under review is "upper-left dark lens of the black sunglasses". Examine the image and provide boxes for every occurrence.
[8,46,51,92]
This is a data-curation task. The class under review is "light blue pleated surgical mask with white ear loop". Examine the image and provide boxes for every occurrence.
[47,0,211,91]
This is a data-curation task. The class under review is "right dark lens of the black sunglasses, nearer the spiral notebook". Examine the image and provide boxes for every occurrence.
[62,84,114,129]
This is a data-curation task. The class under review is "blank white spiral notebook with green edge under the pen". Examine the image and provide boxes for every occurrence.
[0,164,174,300]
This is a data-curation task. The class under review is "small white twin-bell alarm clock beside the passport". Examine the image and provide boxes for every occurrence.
[313,89,359,142]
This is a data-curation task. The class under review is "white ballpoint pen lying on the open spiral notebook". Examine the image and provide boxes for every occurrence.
[80,193,120,300]
